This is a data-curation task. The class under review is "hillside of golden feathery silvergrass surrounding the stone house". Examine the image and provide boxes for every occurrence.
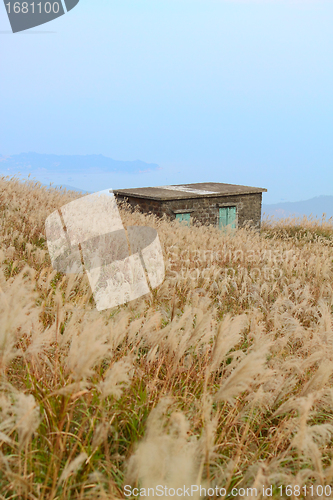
[0,178,333,500]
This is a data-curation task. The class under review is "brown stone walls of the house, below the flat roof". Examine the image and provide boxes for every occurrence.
[116,193,262,229]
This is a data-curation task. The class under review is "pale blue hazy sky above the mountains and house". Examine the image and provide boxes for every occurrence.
[0,0,333,203]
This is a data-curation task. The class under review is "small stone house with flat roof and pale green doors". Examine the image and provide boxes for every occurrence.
[113,182,267,229]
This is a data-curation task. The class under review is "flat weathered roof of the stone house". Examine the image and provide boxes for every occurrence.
[113,182,267,201]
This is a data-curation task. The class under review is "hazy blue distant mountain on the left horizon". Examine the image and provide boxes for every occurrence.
[0,153,159,175]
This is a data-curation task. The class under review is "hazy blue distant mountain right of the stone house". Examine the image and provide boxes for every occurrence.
[262,196,333,219]
